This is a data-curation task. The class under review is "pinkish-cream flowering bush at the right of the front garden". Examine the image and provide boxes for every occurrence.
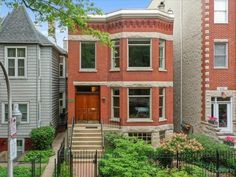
[160,133,204,154]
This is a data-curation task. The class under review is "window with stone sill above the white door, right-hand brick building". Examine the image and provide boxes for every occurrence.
[214,42,228,68]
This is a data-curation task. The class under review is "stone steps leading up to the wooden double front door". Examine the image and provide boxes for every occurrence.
[72,124,103,161]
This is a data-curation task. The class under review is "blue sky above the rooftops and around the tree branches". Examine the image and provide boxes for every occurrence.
[0,0,152,47]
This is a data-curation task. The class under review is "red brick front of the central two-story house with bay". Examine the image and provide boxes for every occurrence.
[68,9,173,142]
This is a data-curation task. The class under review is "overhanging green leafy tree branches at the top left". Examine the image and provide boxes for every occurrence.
[2,0,113,47]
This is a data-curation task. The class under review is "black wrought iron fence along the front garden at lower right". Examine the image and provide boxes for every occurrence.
[155,151,236,177]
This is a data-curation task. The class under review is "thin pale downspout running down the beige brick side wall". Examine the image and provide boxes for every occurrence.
[179,0,183,130]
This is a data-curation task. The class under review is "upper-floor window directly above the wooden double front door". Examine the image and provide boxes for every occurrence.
[80,42,96,71]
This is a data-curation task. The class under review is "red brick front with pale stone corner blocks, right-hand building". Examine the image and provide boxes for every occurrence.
[202,0,236,134]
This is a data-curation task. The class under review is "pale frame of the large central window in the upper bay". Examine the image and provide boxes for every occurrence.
[127,38,153,71]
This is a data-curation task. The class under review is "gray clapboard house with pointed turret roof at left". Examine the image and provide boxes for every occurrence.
[0,6,67,153]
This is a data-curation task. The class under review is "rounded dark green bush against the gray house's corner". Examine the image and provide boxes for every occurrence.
[31,126,55,150]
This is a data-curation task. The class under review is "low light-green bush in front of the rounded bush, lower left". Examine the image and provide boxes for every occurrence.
[23,149,55,163]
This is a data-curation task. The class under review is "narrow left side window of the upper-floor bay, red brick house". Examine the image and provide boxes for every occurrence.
[111,40,120,70]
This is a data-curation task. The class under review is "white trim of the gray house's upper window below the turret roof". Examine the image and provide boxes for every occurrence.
[5,46,28,79]
